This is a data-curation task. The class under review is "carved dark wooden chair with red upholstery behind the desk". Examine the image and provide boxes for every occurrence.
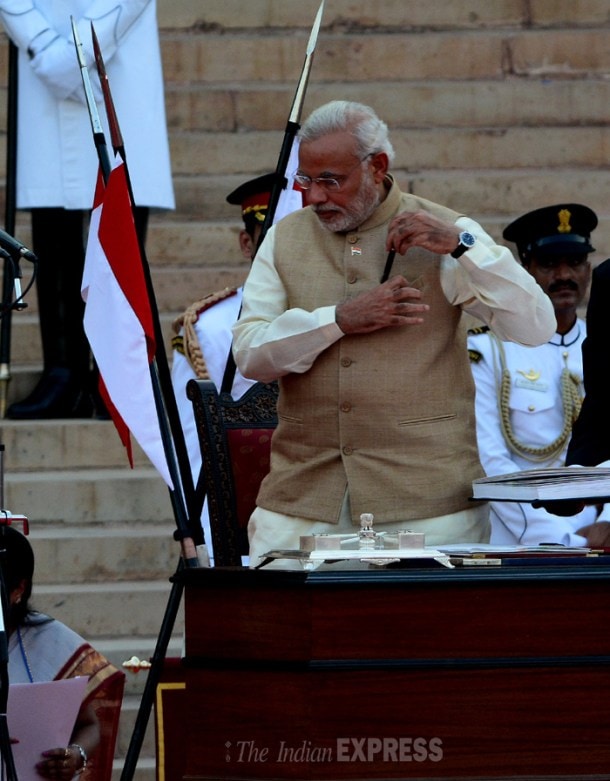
[186,380,278,567]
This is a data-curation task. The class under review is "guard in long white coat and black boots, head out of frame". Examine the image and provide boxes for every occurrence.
[0,0,174,420]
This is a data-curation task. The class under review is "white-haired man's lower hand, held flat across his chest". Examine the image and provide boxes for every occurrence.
[335,276,430,334]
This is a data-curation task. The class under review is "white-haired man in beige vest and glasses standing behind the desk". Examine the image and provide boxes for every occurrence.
[233,101,555,566]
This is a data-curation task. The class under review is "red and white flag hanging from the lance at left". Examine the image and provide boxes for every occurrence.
[81,157,174,490]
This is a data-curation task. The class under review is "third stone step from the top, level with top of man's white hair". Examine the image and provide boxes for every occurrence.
[166,78,608,135]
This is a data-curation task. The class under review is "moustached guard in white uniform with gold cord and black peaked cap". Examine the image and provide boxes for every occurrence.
[468,203,598,546]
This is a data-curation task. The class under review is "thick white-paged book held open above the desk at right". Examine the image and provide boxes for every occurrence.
[472,466,610,503]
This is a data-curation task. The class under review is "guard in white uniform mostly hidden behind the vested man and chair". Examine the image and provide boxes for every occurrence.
[171,173,302,562]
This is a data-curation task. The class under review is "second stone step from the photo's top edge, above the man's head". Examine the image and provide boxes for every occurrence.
[158,25,610,85]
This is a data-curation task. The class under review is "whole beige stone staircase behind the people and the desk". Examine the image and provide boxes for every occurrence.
[0,0,610,781]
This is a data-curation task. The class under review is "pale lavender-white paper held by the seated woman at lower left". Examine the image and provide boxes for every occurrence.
[6,676,88,781]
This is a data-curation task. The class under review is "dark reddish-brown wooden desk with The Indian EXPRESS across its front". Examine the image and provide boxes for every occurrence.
[166,557,610,781]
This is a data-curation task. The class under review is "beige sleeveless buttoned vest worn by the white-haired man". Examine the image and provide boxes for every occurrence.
[258,178,483,524]
